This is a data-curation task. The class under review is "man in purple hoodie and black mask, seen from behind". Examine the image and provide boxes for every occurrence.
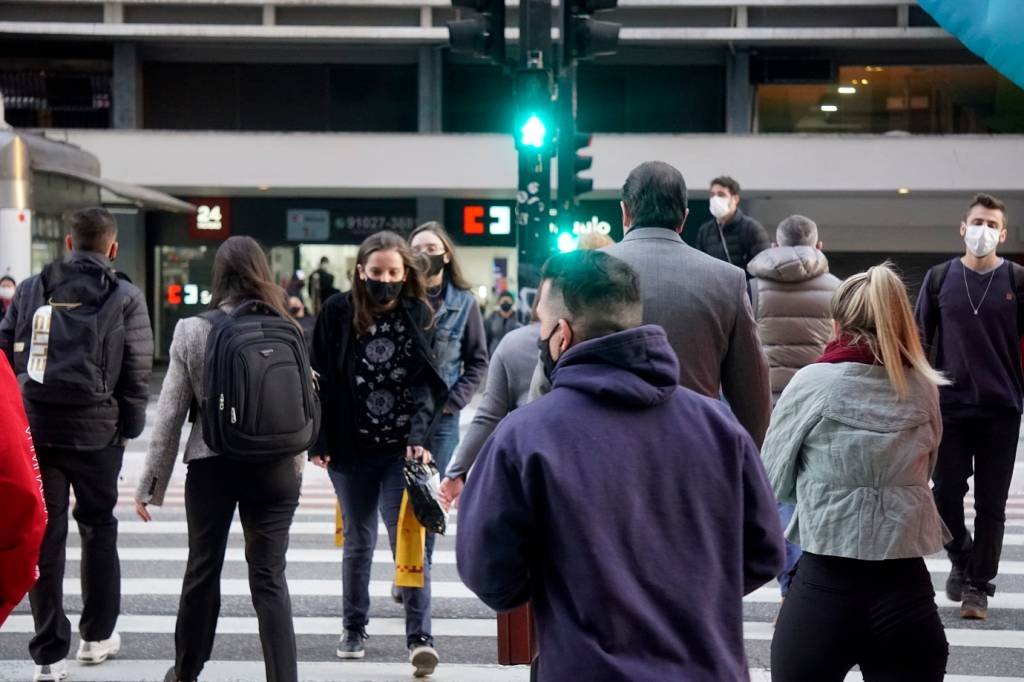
[456,252,783,682]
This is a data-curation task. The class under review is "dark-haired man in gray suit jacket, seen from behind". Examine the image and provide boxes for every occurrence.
[605,161,771,446]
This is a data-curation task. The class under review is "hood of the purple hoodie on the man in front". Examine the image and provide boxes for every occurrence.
[551,325,679,408]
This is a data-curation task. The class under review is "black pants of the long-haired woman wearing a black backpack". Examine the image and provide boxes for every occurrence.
[174,457,299,682]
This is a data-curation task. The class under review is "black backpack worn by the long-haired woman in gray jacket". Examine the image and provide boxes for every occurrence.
[199,301,321,462]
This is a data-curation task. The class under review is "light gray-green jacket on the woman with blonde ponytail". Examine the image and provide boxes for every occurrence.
[761,363,951,561]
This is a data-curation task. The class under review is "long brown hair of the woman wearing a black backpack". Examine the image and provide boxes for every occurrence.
[210,237,294,324]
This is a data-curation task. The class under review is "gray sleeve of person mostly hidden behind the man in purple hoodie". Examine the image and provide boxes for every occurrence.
[444,323,541,478]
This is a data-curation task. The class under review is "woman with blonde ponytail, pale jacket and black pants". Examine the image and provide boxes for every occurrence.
[762,263,949,682]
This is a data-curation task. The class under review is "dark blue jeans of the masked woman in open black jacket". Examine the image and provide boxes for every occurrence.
[328,456,430,642]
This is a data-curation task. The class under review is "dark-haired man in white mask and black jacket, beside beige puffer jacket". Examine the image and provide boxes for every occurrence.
[696,175,769,272]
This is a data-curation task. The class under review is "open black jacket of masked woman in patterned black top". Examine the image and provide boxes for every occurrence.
[309,294,447,469]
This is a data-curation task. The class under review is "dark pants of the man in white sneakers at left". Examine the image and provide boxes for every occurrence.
[29,445,125,666]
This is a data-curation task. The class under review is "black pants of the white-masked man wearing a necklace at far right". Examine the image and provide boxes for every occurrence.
[932,405,1021,587]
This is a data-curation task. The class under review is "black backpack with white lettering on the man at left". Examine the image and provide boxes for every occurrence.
[23,262,125,406]
